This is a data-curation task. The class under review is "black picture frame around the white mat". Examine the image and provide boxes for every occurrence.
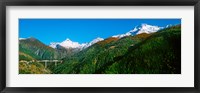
[0,0,200,93]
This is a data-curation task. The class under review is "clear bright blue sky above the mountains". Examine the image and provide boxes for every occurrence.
[19,19,181,45]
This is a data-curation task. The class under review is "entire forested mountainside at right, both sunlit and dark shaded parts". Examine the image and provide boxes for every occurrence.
[53,25,181,74]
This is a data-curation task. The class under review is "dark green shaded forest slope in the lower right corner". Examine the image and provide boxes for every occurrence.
[106,26,181,74]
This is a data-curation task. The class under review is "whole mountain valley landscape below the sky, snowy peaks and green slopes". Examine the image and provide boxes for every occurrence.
[19,24,181,74]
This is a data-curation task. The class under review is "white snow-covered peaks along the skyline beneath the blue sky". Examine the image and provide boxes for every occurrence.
[45,24,172,50]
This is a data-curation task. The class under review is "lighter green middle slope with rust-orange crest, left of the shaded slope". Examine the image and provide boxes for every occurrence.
[54,34,150,73]
